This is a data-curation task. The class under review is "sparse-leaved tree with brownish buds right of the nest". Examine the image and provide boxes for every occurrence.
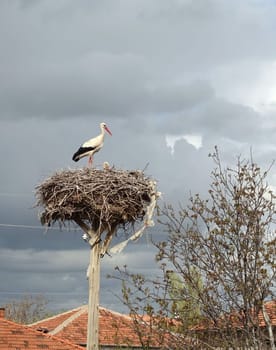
[115,148,276,349]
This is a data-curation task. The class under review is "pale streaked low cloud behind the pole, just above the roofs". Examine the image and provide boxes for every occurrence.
[0,234,158,311]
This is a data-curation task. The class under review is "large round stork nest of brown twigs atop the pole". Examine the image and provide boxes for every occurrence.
[36,168,154,230]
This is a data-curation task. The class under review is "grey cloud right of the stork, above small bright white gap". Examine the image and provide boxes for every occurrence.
[162,96,274,145]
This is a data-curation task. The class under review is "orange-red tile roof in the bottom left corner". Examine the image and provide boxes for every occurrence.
[0,309,83,350]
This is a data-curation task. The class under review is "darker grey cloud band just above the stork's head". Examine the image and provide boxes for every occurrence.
[1,62,213,119]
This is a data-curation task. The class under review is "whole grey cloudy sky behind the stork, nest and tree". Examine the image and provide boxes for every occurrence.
[0,0,276,311]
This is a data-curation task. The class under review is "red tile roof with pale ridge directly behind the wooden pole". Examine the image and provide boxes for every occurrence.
[30,305,168,348]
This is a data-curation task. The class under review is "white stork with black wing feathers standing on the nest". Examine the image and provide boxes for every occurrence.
[72,123,112,166]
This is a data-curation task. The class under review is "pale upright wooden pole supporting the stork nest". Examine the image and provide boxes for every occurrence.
[86,239,101,350]
